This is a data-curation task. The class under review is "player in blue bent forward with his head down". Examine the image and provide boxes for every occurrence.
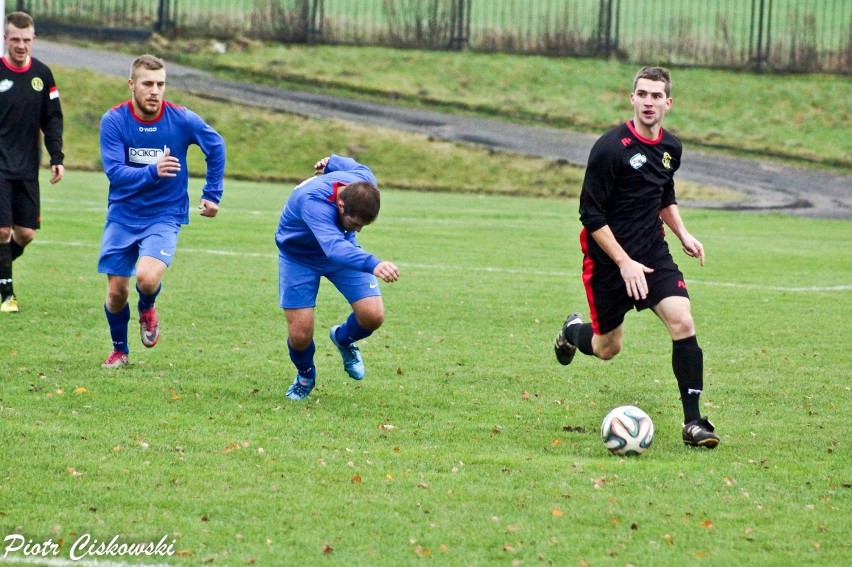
[275,155,399,400]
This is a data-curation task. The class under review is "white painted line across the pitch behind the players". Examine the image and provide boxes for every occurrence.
[33,240,852,293]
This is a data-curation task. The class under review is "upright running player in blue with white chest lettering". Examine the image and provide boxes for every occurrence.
[98,55,225,368]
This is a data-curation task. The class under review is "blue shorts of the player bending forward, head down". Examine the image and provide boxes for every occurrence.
[278,252,382,309]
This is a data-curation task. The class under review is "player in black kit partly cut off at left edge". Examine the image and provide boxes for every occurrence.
[0,12,65,313]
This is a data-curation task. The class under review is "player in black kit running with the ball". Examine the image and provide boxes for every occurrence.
[554,67,719,449]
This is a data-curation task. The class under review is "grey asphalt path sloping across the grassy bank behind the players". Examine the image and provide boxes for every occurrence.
[33,38,852,219]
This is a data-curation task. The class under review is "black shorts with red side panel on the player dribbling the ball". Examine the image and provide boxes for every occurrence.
[583,248,689,335]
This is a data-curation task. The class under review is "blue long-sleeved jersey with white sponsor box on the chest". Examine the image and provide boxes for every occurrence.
[101,101,225,225]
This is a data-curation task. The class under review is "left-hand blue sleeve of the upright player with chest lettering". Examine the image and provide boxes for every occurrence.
[101,110,159,200]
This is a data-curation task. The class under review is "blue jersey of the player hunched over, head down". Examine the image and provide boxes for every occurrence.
[275,155,380,273]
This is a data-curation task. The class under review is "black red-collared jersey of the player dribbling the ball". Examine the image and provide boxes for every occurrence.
[580,121,683,263]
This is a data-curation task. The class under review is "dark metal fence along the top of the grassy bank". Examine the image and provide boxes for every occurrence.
[13,0,852,74]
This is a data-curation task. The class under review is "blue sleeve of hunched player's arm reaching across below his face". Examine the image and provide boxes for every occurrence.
[302,193,380,273]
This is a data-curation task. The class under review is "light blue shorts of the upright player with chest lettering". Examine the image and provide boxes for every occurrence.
[98,221,180,278]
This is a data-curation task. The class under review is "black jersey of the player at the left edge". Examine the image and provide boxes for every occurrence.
[0,57,65,180]
